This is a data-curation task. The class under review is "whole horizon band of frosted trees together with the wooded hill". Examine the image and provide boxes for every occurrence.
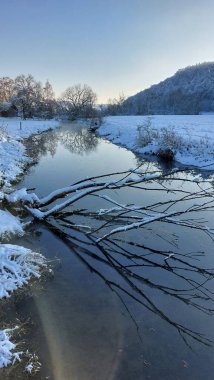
[3,63,214,120]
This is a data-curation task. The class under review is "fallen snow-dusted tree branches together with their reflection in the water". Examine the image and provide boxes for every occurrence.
[2,167,214,345]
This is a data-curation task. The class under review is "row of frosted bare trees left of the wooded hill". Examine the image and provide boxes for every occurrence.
[0,75,98,120]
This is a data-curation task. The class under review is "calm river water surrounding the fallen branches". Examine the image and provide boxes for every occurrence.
[8,124,214,380]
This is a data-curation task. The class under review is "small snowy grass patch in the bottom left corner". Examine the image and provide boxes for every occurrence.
[0,327,21,368]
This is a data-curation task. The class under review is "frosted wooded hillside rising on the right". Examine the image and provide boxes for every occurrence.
[123,62,214,115]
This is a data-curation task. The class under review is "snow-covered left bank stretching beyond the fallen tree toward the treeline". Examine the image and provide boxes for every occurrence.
[0,118,59,186]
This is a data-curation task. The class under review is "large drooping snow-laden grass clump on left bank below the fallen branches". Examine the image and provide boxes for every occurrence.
[0,244,46,299]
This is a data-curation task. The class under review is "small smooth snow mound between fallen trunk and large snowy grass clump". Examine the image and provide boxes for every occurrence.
[0,210,24,239]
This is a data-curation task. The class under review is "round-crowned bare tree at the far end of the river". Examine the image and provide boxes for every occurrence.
[61,84,97,120]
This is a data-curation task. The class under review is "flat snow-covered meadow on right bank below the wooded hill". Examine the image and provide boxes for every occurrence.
[98,115,214,169]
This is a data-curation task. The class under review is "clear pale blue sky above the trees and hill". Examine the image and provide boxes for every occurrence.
[0,0,214,102]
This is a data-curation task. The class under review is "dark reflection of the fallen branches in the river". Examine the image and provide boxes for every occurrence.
[46,219,214,347]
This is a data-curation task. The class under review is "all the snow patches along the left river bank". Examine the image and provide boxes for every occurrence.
[0,118,59,371]
